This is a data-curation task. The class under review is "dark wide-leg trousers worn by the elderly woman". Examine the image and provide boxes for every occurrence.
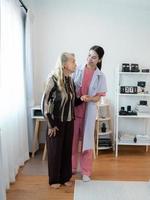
[46,121,74,185]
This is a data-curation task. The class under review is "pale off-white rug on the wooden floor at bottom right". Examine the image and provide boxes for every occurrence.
[74,180,150,200]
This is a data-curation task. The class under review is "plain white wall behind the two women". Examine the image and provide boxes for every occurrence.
[24,0,150,144]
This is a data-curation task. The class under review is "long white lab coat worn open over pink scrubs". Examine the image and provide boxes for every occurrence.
[73,66,107,151]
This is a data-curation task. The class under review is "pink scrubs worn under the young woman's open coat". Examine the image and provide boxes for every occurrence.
[72,67,94,176]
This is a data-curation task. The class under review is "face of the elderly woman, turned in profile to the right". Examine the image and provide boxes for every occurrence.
[64,56,77,73]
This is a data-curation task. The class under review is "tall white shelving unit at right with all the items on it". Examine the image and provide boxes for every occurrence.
[116,63,150,157]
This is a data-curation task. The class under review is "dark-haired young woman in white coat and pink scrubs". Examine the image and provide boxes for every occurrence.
[72,46,106,181]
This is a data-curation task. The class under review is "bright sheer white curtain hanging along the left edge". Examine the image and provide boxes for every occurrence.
[0,0,29,198]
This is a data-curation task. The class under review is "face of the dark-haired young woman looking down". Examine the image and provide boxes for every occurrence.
[87,50,101,67]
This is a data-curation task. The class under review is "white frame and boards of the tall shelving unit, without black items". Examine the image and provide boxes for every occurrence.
[115,69,150,157]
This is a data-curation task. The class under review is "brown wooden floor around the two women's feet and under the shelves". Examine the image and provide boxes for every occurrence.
[7,147,150,200]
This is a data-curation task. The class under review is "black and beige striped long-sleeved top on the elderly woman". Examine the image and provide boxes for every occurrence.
[41,75,82,127]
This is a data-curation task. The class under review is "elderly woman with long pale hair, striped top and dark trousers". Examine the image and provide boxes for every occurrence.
[42,52,82,188]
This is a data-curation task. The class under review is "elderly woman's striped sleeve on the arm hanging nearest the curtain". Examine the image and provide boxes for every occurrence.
[41,77,55,127]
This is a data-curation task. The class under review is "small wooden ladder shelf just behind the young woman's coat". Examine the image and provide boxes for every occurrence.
[96,102,112,156]
